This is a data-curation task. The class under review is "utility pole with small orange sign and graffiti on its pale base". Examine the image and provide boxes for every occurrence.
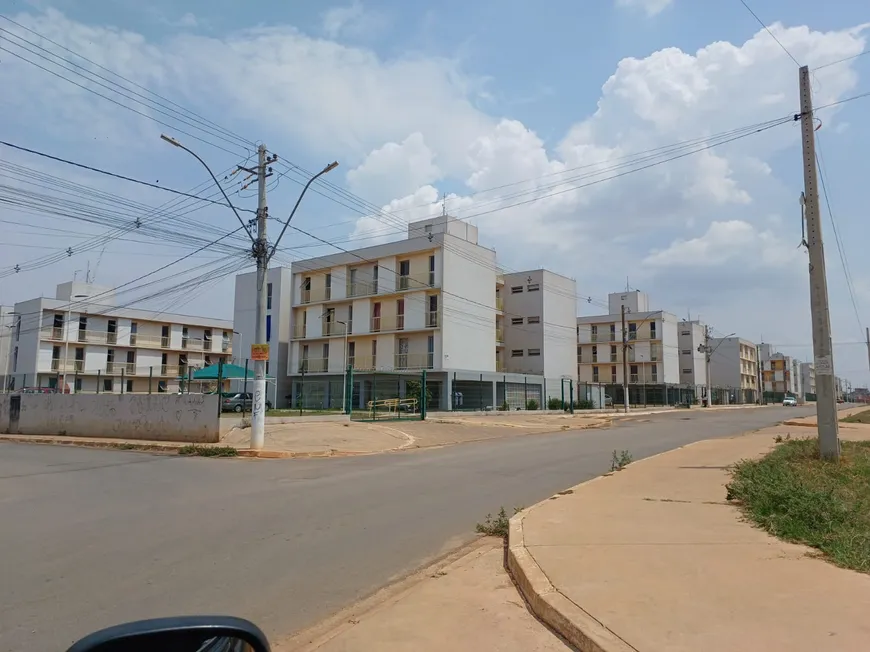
[251,143,269,450]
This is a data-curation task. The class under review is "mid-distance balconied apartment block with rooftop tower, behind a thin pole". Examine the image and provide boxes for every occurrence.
[577,290,693,404]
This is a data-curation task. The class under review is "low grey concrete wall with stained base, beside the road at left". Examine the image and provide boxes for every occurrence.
[0,394,220,443]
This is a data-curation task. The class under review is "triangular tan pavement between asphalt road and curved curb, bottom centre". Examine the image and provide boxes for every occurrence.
[273,538,570,652]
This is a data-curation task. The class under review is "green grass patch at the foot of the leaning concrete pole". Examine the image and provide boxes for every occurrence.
[726,439,870,573]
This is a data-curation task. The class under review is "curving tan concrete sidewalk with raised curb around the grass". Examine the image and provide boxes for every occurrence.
[509,424,870,652]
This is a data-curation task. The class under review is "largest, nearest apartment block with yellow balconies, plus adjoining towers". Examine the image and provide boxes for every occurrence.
[235,216,576,409]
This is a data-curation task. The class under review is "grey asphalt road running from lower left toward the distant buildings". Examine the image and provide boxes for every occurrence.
[0,407,812,652]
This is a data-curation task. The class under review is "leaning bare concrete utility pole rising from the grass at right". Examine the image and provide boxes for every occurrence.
[799,66,840,461]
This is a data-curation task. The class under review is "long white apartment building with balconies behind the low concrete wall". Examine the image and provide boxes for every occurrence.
[8,282,233,393]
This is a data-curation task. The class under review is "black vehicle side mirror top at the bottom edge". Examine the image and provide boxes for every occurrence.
[67,616,269,652]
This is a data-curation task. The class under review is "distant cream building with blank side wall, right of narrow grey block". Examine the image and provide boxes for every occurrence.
[710,337,758,403]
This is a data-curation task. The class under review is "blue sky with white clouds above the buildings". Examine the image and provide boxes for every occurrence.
[0,0,870,386]
